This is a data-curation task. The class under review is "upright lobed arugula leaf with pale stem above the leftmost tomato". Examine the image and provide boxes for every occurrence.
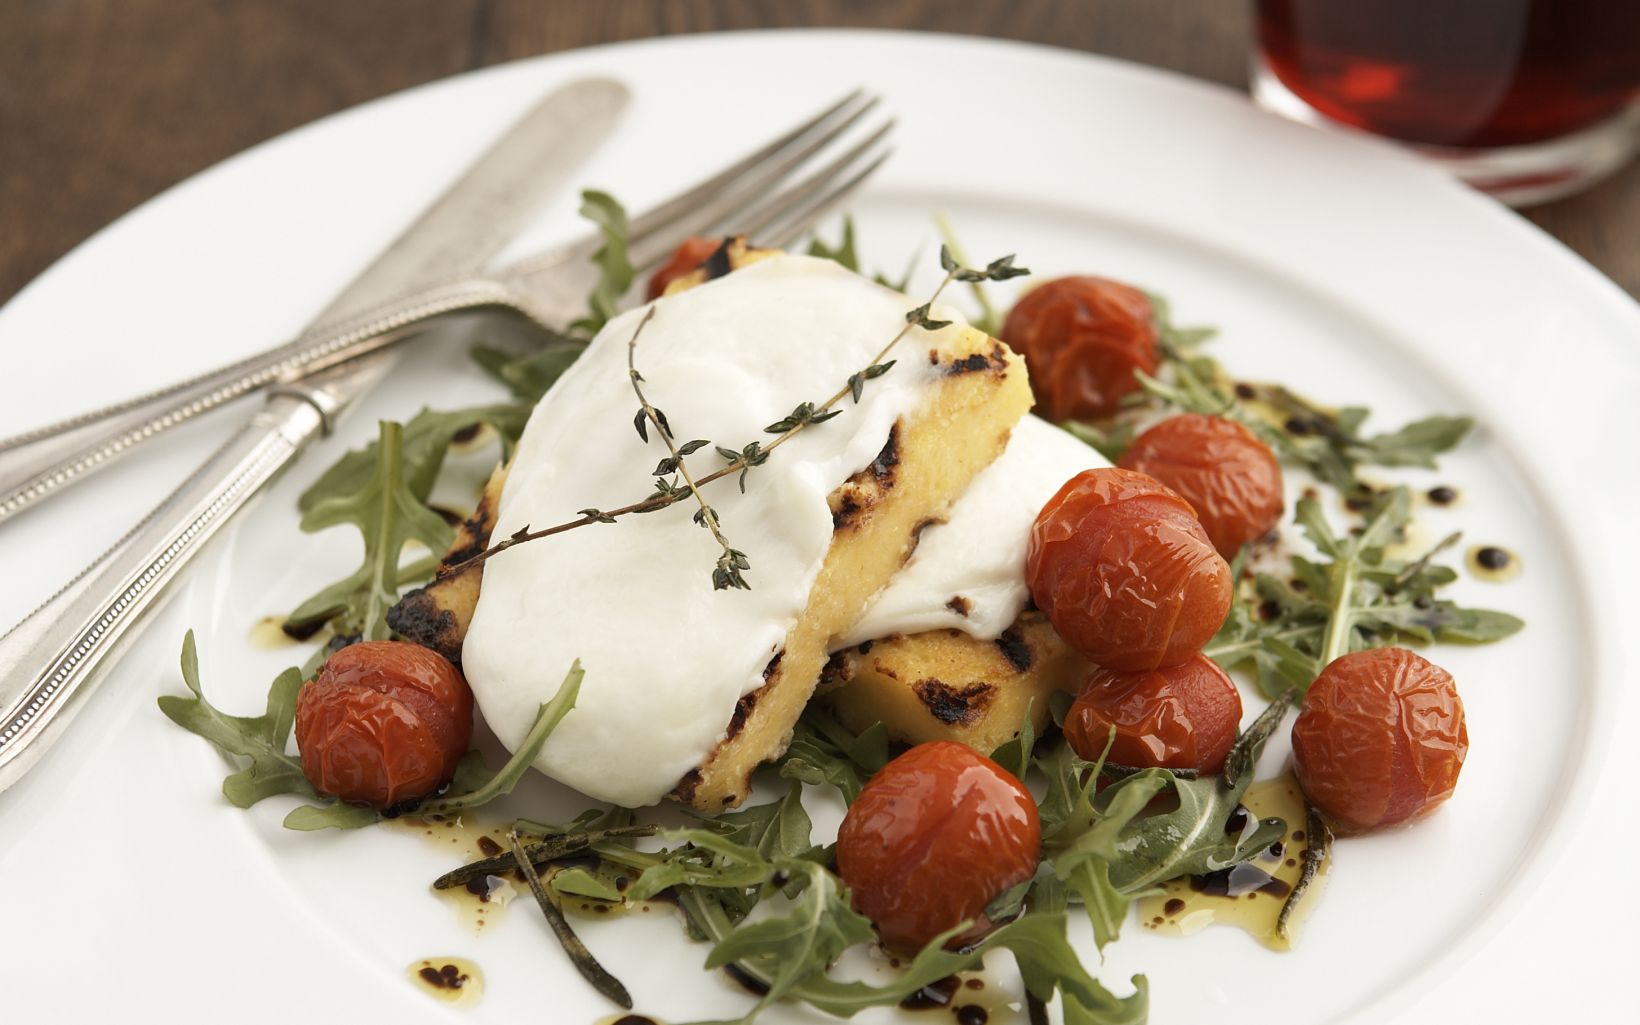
[287,420,453,640]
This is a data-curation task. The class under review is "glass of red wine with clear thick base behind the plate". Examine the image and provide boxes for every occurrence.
[1253,0,1640,207]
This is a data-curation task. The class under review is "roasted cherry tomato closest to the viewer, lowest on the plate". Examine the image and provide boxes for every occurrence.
[836,740,1041,951]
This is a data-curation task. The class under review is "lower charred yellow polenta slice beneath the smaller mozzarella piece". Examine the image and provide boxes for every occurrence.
[820,608,1091,754]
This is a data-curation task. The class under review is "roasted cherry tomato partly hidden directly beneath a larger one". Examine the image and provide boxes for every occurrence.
[1064,653,1241,774]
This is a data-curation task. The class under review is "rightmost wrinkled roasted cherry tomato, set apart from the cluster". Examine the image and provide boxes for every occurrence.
[1292,648,1469,833]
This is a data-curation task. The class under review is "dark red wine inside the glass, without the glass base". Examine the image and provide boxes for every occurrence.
[1258,0,1640,148]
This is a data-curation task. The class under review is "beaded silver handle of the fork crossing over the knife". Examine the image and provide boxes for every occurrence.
[0,280,517,522]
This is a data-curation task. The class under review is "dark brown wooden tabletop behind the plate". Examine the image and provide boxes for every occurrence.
[0,0,1640,302]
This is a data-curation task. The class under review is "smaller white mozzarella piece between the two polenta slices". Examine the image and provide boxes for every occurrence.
[833,417,1110,649]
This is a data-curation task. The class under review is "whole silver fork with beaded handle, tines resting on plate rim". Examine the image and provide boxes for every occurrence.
[0,90,894,522]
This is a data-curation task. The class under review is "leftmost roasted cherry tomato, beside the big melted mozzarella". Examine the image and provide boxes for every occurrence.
[297,641,472,809]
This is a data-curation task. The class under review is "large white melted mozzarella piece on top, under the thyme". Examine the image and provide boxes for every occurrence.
[462,256,956,807]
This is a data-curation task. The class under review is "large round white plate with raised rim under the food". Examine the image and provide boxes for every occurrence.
[0,33,1640,1025]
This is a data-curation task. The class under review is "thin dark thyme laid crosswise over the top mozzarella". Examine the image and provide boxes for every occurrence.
[440,246,1030,590]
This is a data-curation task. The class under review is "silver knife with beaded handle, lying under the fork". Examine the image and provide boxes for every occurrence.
[0,79,628,790]
